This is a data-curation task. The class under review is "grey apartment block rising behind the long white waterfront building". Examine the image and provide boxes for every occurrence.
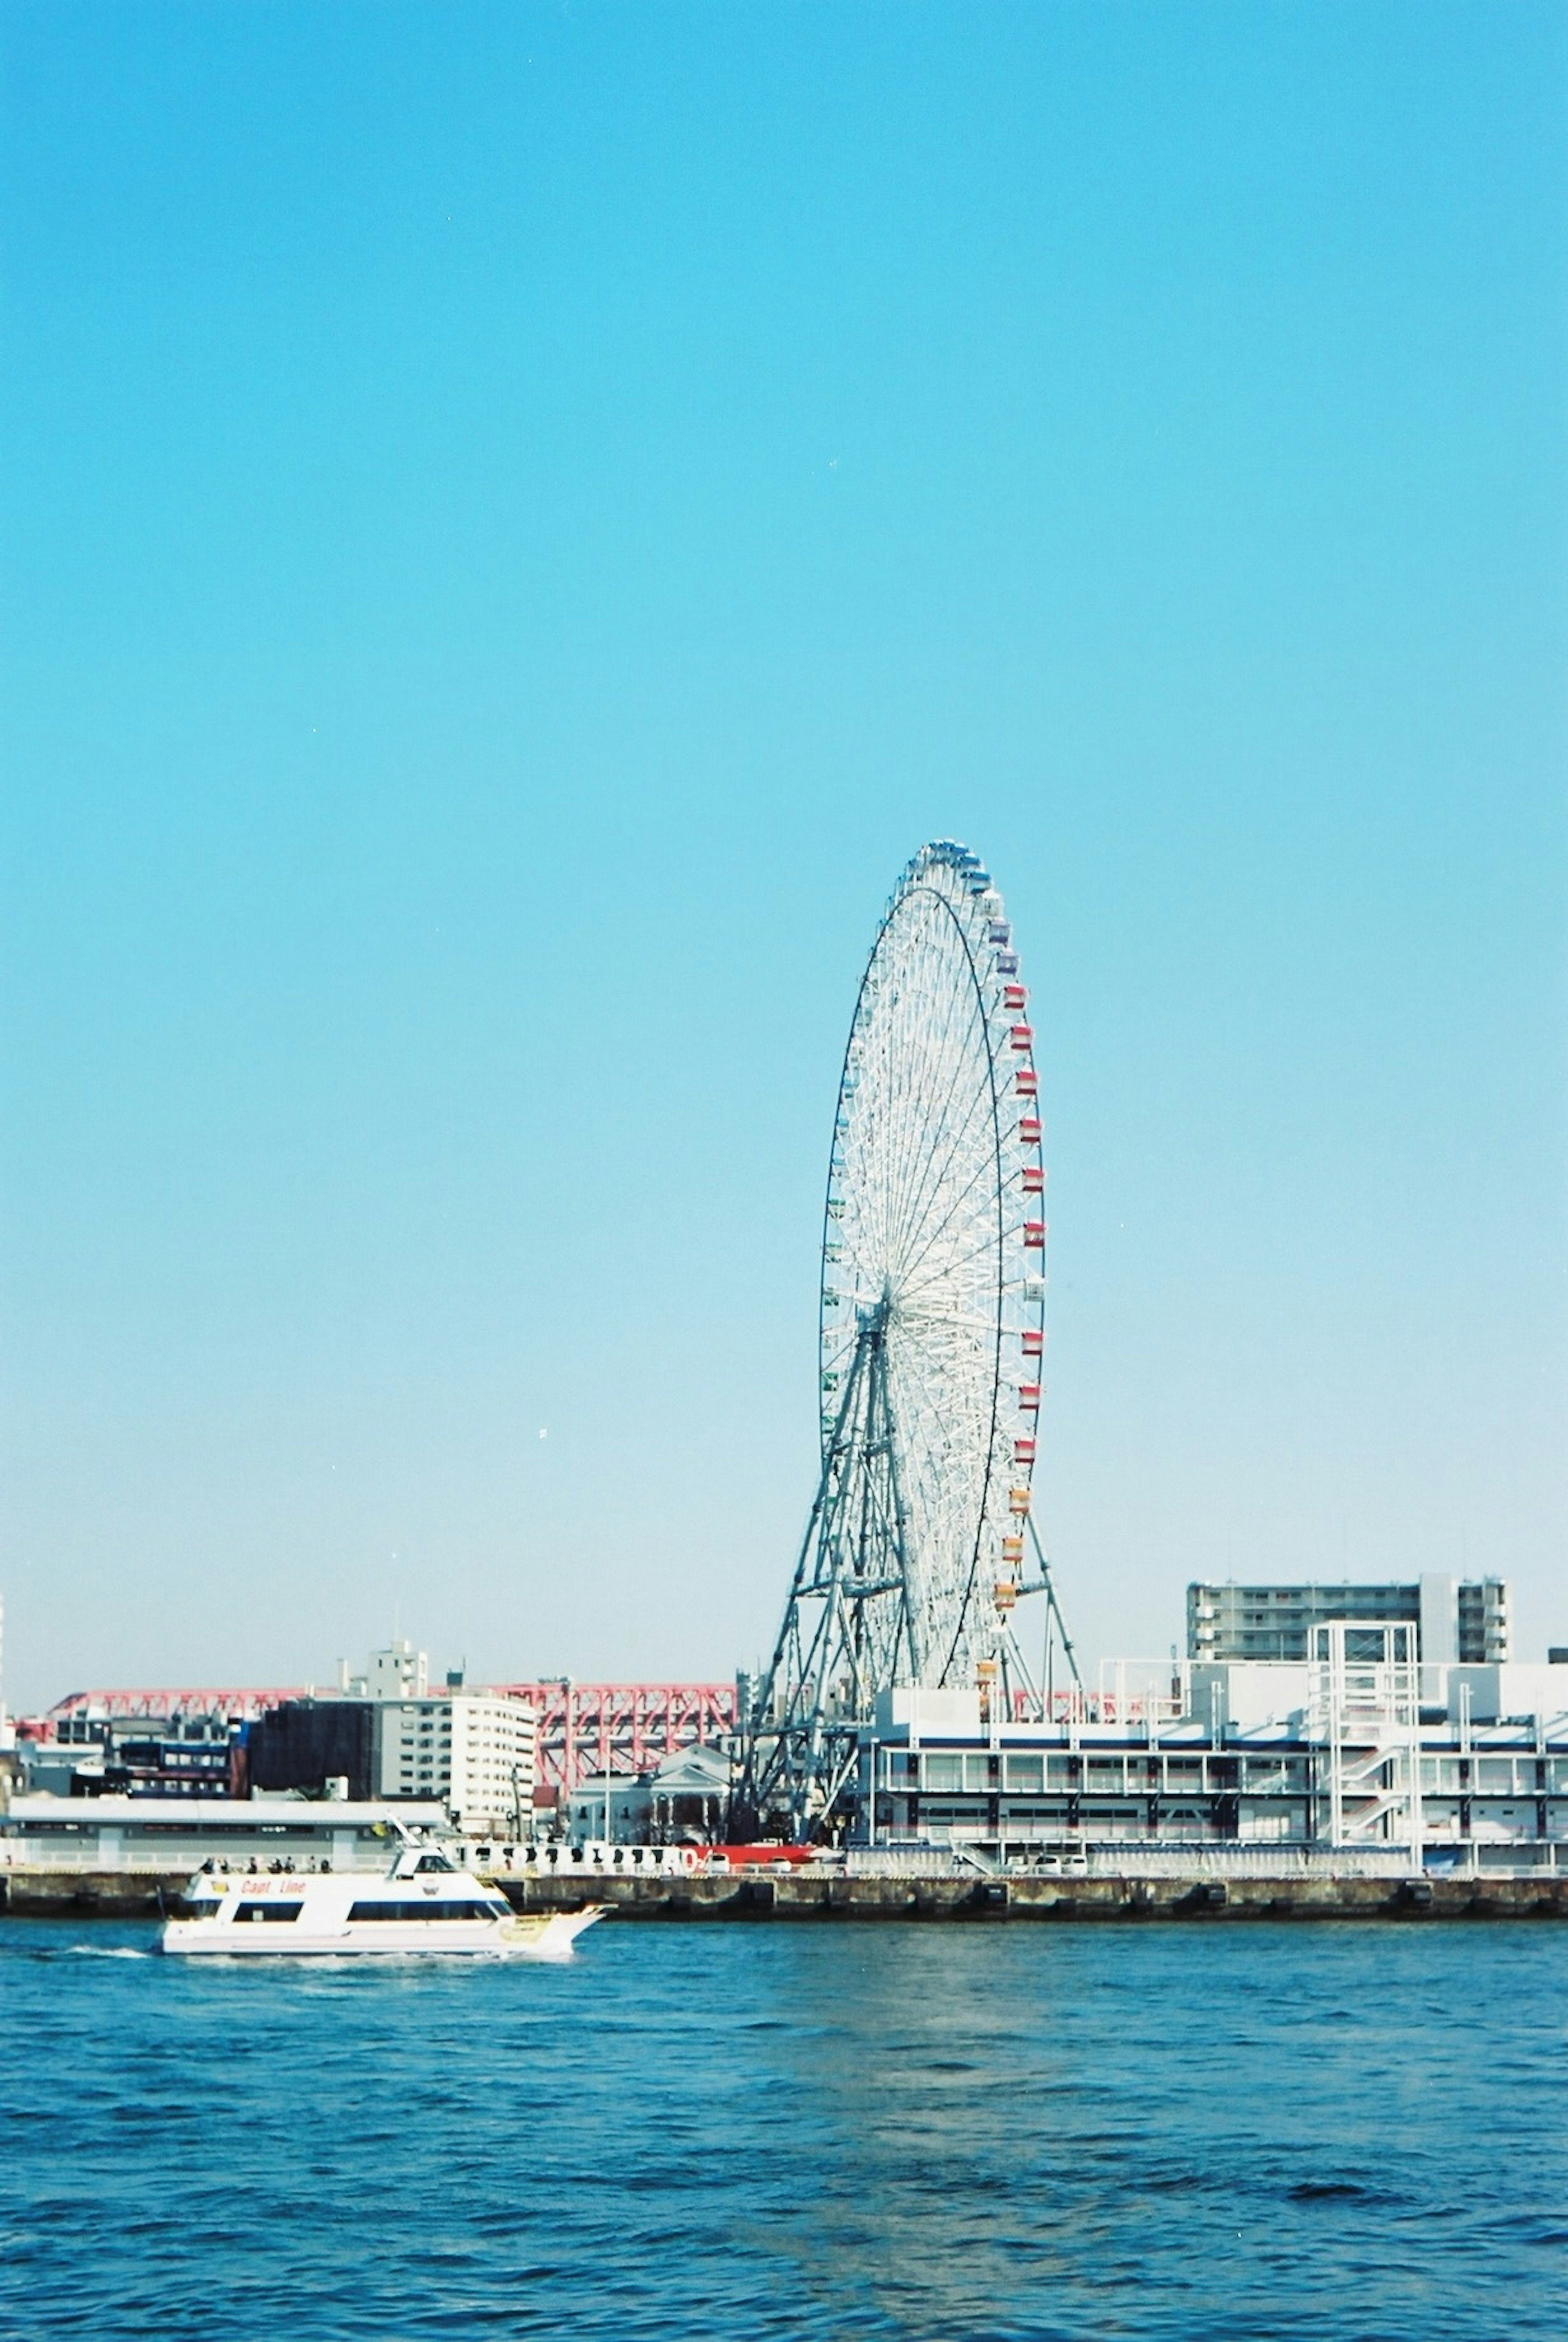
[1187,1569,1510,1665]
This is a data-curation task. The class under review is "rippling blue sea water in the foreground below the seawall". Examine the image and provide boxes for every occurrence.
[0,1921,1568,2342]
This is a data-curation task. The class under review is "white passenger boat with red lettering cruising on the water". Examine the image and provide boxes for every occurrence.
[161,1845,604,1960]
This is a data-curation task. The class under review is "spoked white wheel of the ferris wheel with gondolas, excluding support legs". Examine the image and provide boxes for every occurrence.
[822,843,1046,1684]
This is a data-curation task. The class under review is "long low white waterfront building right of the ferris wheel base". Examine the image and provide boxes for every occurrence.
[854,1621,1568,1876]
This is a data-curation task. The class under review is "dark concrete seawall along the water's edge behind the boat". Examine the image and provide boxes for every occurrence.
[2,1869,1568,1925]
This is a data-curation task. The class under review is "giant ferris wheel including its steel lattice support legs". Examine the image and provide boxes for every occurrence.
[744,841,1062,1825]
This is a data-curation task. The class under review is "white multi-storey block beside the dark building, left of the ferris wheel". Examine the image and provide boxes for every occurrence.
[377,1689,534,1836]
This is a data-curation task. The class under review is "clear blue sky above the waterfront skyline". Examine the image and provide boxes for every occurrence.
[0,0,1568,1705]
